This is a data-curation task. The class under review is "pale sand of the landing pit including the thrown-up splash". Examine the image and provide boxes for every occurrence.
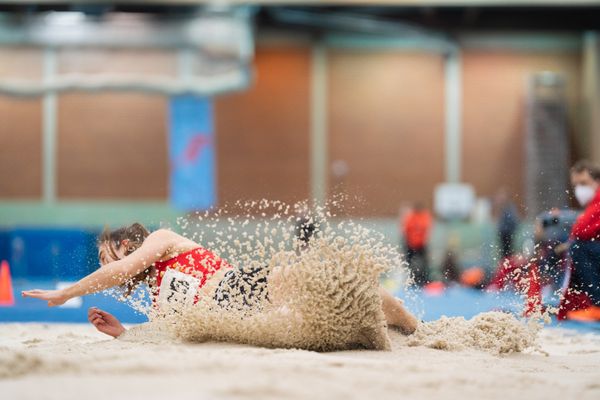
[5,203,600,400]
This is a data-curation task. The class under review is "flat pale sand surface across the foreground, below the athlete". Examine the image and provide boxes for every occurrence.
[0,324,600,400]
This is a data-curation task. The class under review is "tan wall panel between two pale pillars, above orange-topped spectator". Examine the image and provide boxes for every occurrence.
[328,50,444,216]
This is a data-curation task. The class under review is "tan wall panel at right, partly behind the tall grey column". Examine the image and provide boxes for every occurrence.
[462,50,580,205]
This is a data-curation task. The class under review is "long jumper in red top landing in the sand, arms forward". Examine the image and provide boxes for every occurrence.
[22,223,417,337]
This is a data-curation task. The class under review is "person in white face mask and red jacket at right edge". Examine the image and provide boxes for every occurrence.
[559,160,600,320]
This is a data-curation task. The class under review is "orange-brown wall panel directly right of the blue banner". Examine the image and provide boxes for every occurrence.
[215,47,310,204]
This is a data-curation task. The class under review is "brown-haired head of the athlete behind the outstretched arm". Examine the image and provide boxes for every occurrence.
[98,222,150,265]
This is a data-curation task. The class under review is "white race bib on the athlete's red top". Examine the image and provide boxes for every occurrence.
[158,268,200,311]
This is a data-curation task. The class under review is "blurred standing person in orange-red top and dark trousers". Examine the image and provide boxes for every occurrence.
[400,203,433,286]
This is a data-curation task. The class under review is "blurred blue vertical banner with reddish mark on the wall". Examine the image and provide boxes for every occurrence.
[169,95,216,211]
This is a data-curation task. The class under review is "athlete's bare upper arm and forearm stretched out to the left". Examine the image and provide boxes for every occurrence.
[22,230,174,306]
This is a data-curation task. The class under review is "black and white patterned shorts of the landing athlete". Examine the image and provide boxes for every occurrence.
[214,267,268,310]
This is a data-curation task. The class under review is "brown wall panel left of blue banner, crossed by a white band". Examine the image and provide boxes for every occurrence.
[57,49,176,200]
